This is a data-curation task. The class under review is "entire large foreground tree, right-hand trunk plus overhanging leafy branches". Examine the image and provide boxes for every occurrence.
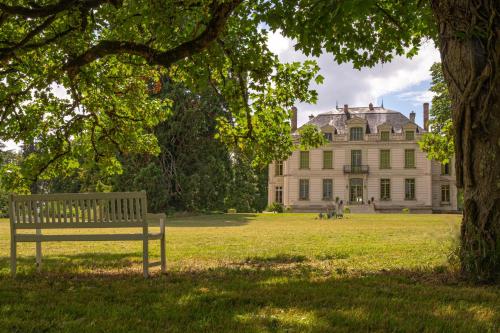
[0,0,500,280]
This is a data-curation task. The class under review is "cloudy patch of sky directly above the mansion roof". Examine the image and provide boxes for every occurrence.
[268,31,440,126]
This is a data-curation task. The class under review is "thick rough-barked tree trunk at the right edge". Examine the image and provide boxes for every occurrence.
[431,0,500,281]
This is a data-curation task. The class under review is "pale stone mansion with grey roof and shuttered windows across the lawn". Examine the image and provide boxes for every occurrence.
[268,103,457,212]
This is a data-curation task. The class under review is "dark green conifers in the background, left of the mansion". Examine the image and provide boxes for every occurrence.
[112,79,267,212]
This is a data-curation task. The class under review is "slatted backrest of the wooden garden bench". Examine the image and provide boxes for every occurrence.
[9,192,147,229]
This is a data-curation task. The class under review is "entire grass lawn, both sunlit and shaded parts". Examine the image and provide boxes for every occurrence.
[0,214,500,333]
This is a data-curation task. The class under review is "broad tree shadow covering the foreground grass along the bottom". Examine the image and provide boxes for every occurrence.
[0,253,500,332]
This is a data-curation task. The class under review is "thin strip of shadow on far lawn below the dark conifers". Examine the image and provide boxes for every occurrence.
[167,214,257,228]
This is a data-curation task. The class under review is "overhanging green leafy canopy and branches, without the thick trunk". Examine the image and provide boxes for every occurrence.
[0,0,432,191]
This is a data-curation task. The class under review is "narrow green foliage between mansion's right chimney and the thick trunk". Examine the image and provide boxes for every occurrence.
[419,63,455,164]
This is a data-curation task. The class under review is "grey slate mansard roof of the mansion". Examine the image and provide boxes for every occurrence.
[298,107,424,134]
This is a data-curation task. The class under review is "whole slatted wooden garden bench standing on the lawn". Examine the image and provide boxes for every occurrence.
[9,192,166,277]
